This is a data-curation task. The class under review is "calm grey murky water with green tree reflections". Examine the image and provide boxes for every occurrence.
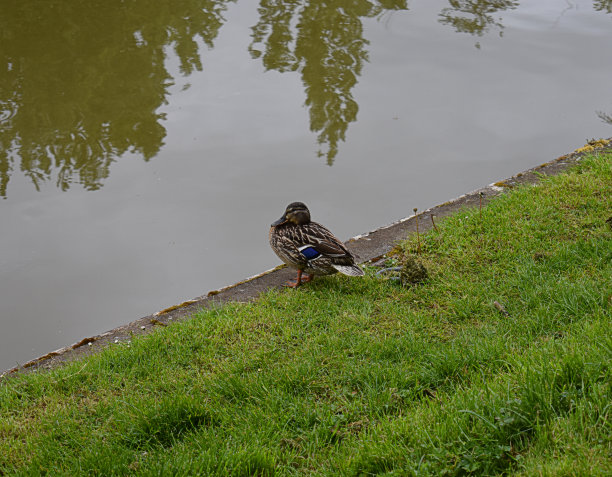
[0,0,612,369]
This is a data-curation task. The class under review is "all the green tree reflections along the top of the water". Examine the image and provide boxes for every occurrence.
[0,0,612,197]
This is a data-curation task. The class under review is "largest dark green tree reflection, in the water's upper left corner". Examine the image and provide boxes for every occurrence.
[0,0,233,197]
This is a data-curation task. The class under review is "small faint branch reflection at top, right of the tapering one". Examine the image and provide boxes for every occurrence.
[440,0,519,36]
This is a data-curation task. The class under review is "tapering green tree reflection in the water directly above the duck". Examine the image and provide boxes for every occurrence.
[249,0,407,165]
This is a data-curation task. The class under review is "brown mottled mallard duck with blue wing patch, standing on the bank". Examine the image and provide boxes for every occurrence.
[269,202,364,288]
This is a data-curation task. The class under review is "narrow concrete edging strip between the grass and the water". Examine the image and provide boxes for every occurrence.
[0,139,612,378]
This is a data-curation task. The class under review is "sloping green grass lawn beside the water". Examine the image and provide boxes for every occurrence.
[0,154,612,476]
